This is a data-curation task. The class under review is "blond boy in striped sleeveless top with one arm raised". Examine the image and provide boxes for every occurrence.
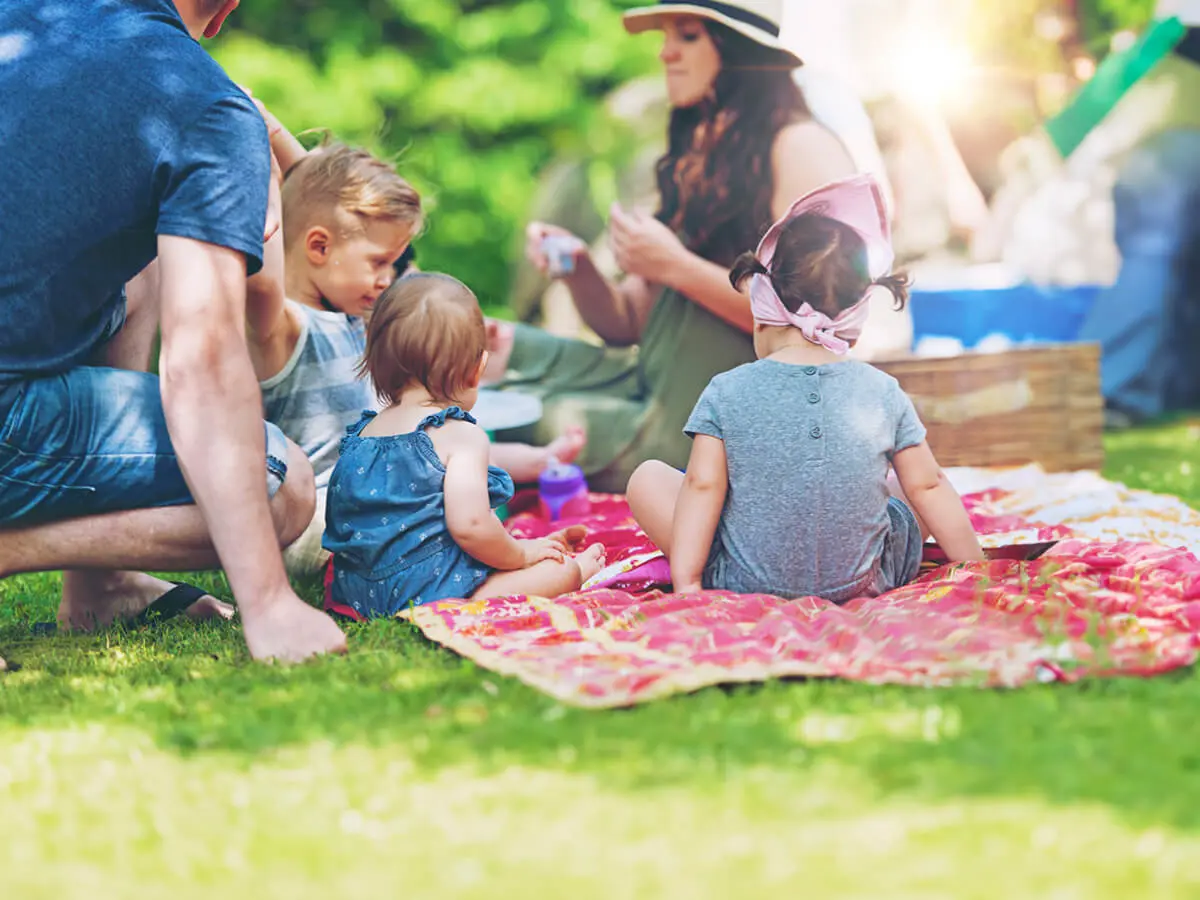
[247,116,583,576]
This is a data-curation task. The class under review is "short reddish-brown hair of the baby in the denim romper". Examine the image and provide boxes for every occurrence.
[360,272,487,403]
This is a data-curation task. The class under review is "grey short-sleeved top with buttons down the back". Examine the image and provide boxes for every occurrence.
[684,360,925,596]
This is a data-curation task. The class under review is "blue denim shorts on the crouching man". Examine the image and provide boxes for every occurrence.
[0,366,288,527]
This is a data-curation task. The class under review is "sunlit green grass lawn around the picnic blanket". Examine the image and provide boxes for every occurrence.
[0,422,1200,900]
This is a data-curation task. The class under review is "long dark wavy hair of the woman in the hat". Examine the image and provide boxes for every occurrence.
[656,20,810,265]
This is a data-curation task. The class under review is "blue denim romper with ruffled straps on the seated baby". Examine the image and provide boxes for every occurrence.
[323,407,514,618]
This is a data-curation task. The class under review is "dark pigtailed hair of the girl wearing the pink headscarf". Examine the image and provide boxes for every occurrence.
[730,212,908,319]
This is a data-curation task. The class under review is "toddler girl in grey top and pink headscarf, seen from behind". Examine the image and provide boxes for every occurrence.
[629,175,984,602]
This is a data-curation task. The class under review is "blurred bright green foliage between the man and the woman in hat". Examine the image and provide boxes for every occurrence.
[212,0,656,306]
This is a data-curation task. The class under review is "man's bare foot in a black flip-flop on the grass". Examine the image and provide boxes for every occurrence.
[59,569,234,631]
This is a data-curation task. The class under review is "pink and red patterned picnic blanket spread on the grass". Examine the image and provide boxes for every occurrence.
[412,467,1200,707]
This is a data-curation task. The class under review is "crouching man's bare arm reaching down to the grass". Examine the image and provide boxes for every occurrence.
[158,235,346,660]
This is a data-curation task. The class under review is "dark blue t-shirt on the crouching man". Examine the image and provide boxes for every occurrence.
[0,0,270,380]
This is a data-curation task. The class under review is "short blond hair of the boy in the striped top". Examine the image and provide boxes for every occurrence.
[283,143,421,247]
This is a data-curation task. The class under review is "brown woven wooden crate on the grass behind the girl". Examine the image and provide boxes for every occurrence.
[874,343,1104,472]
